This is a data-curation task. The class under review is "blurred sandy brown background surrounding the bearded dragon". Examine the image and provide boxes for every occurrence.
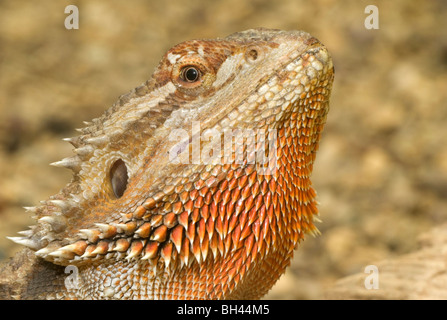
[0,0,447,299]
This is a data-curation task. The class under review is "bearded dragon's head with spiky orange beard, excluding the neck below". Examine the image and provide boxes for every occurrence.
[11,29,333,276]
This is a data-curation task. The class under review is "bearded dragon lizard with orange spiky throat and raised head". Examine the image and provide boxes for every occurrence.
[0,28,334,299]
